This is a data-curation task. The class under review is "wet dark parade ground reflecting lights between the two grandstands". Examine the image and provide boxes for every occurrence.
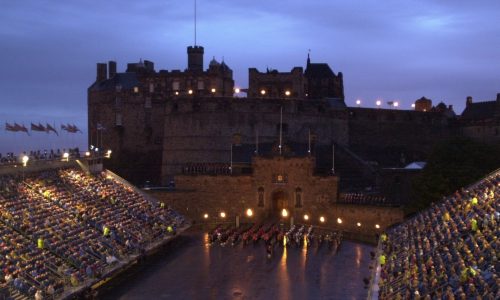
[98,232,374,299]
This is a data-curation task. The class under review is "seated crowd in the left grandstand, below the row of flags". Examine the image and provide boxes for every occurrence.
[0,169,184,298]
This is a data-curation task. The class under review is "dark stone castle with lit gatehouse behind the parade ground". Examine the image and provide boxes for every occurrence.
[88,46,500,230]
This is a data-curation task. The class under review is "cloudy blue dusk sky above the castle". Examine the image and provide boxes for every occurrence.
[0,0,500,153]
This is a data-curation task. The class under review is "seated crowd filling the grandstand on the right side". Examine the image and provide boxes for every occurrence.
[379,172,500,299]
